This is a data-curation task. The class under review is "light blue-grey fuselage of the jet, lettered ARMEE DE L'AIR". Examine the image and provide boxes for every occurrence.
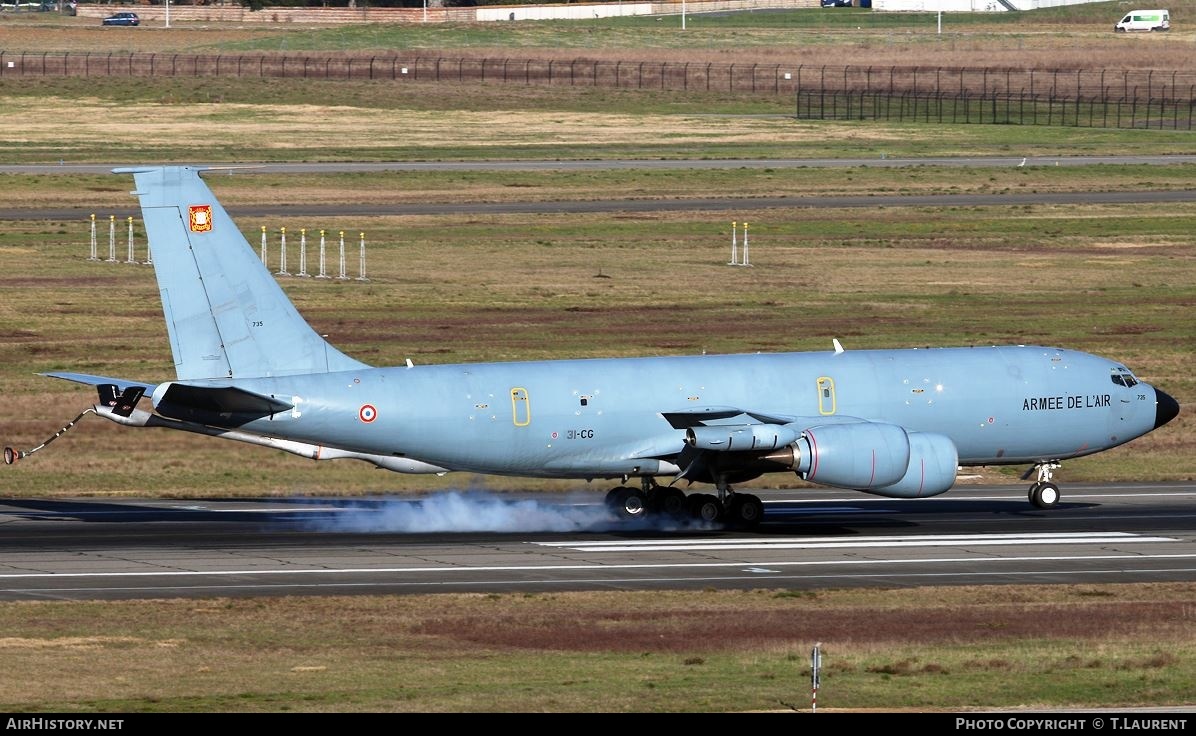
[212,346,1155,478]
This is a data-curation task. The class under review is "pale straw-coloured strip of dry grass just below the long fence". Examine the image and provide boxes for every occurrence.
[4,97,897,152]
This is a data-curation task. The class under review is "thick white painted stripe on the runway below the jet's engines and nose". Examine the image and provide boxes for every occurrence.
[526,531,1178,552]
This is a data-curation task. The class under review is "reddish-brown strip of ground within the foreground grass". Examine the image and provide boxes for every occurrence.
[416,601,1190,652]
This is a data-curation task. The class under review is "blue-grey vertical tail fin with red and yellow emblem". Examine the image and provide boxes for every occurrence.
[115,166,367,381]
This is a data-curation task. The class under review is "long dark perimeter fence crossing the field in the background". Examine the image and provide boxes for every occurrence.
[0,51,1196,130]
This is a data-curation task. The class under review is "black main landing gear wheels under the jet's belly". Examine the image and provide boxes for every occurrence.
[606,478,764,529]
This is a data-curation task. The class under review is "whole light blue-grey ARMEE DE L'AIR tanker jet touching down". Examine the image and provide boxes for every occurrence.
[5,166,1179,527]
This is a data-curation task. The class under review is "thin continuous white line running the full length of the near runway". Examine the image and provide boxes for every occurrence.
[0,553,1196,579]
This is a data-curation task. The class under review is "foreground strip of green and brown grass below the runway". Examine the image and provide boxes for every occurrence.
[0,584,1196,711]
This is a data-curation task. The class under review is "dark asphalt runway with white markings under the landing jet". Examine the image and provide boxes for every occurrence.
[0,482,1196,601]
